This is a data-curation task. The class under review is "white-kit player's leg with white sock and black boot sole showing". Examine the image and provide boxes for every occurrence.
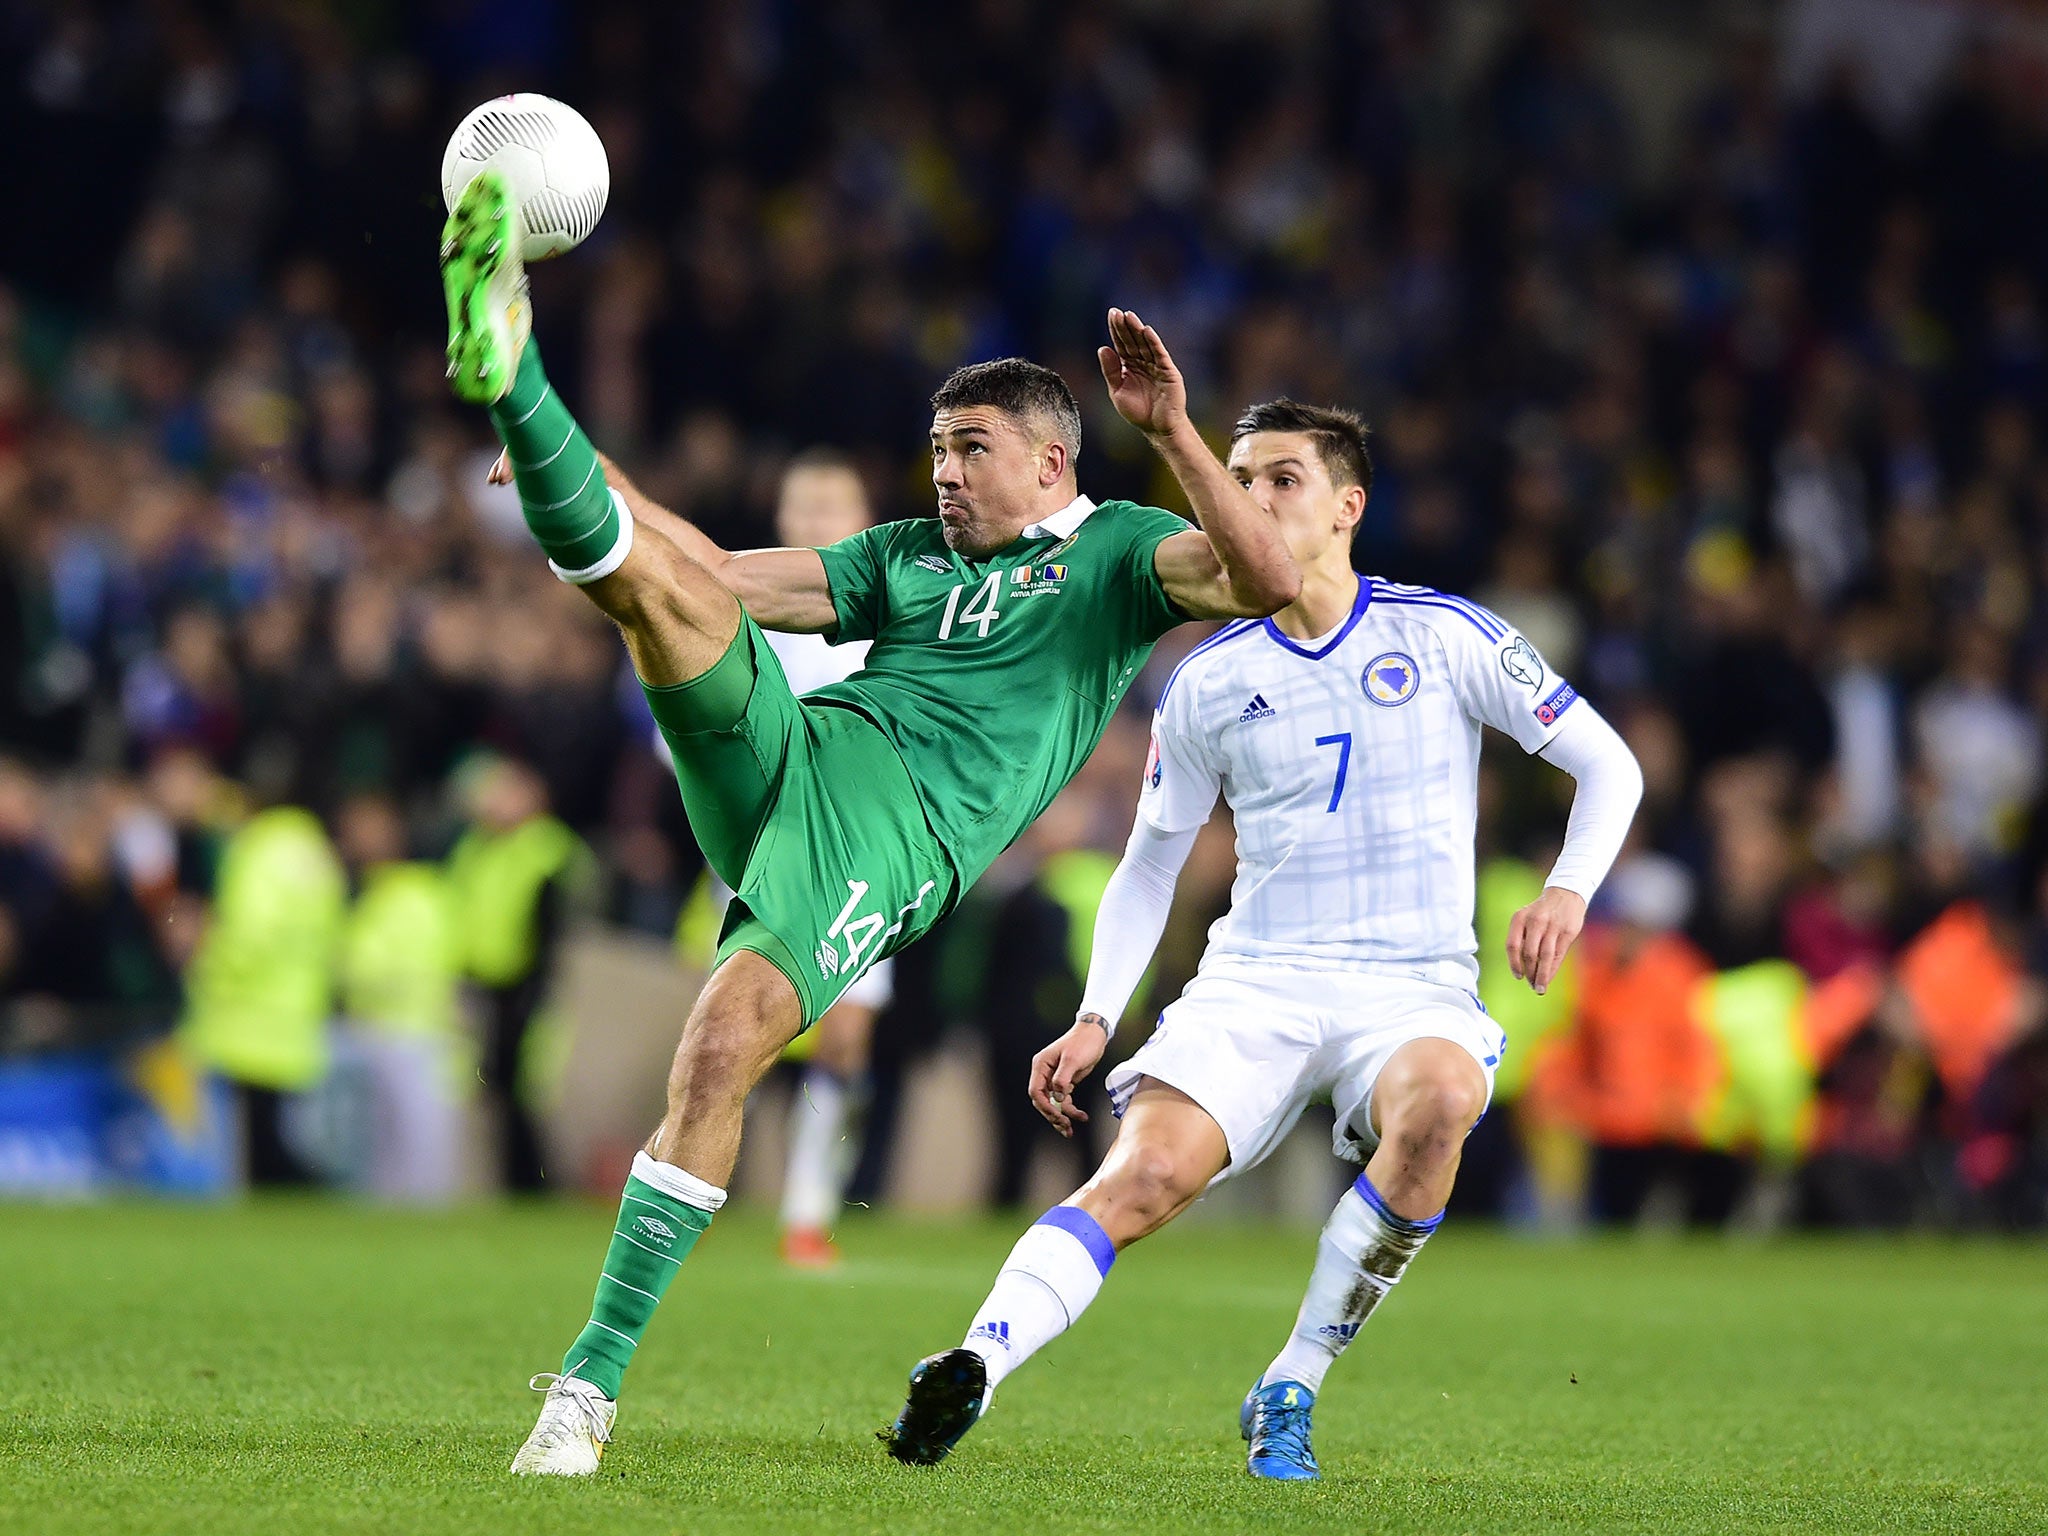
[881,1079,1231,1466]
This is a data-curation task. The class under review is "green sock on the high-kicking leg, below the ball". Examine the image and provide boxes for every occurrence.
[492,338,623,580]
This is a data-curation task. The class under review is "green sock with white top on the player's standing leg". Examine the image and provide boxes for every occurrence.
[561,1153,725,1399]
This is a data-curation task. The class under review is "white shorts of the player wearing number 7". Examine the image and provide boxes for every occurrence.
[1106,958,1507,1182]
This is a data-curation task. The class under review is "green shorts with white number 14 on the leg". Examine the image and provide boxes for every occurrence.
[647,618,958,1028]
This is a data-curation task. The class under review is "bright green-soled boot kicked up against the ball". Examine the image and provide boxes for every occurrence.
[440,170,532,406]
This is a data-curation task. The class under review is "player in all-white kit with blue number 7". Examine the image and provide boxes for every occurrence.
[887,399,1642,1481]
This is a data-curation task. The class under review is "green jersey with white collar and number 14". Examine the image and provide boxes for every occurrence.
[807,498,1188,887]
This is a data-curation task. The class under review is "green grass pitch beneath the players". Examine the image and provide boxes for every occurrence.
[0,1202,2048,1536]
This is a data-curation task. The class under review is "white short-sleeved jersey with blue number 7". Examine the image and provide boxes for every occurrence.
[1139,578,1577,979]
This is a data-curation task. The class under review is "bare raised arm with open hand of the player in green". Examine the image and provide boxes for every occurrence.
[1096,309,1300,618]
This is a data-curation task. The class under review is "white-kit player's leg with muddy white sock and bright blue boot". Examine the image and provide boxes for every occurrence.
[1237,1040,1487,1481]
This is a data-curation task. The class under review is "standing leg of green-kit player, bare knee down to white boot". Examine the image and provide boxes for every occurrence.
[512,950,803,1477]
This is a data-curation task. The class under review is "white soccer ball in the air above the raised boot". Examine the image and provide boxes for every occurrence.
[440,90,612,262]
